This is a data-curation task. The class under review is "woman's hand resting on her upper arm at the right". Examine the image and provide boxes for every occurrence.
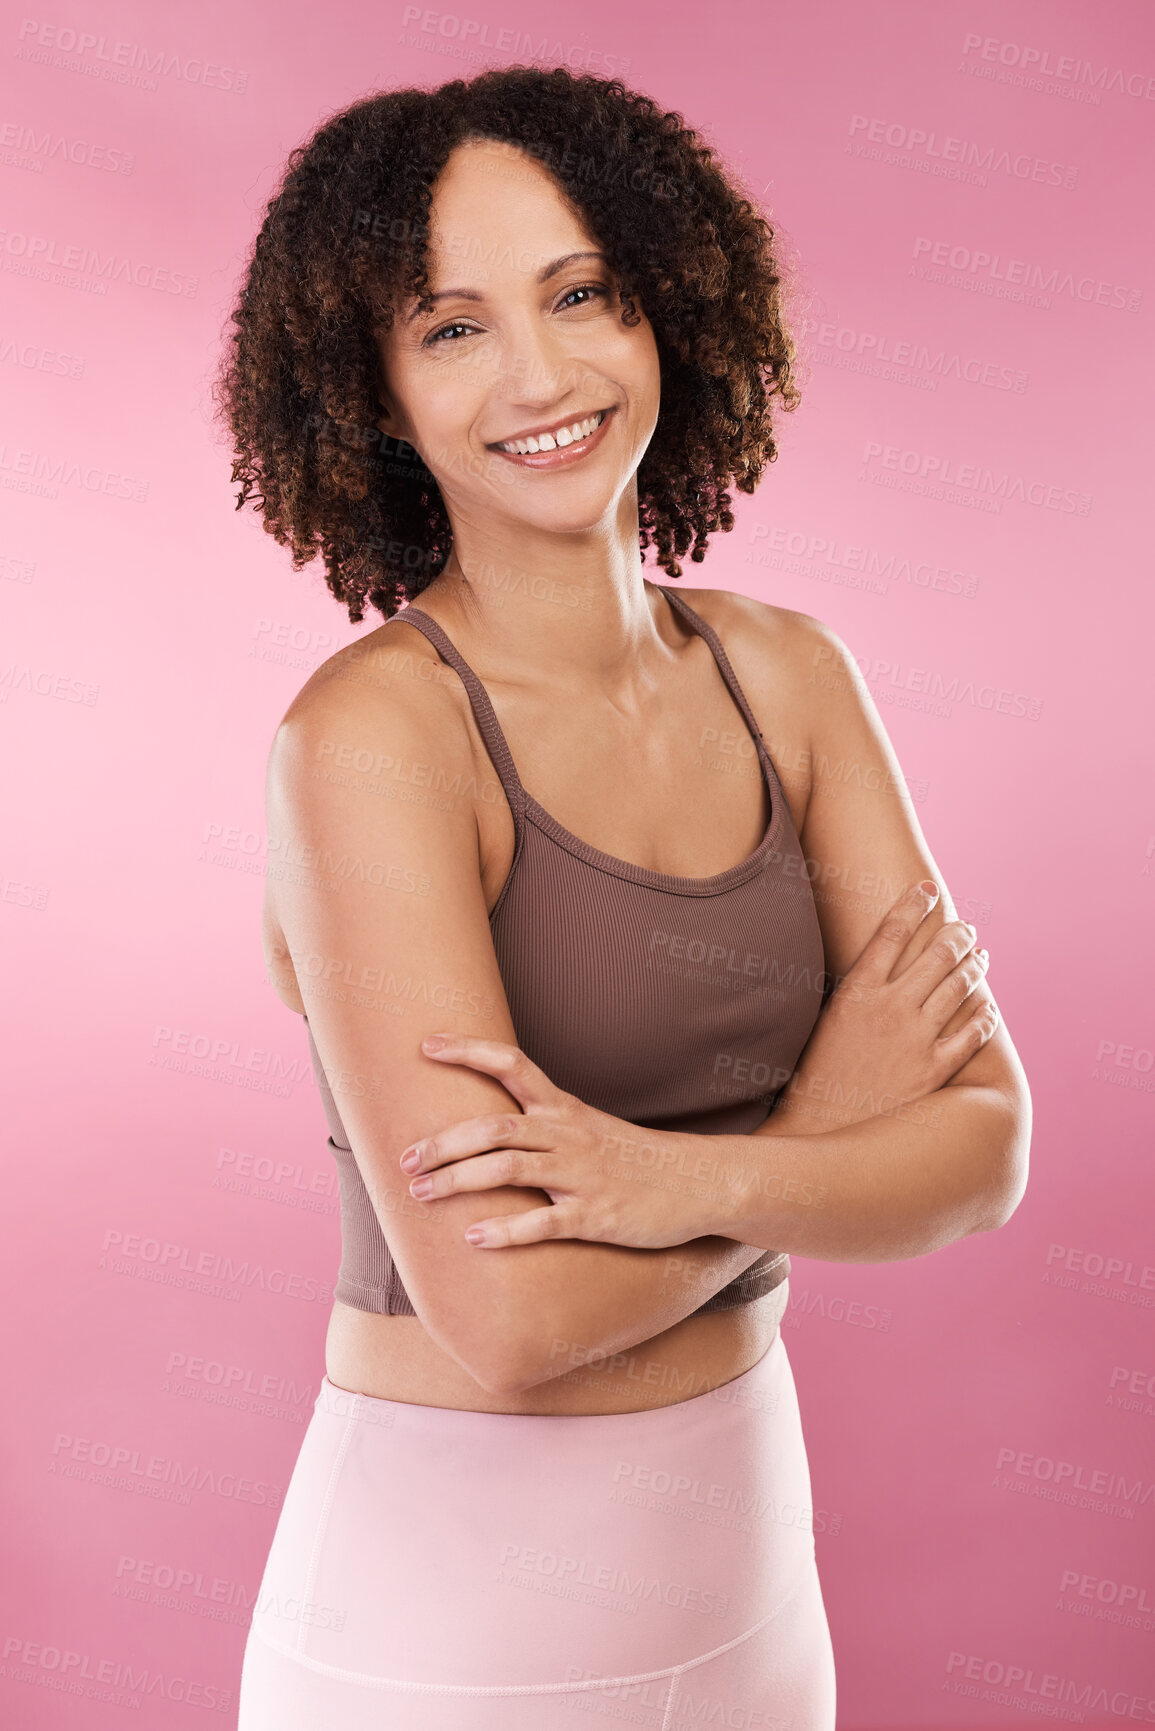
[767,883,999,1136]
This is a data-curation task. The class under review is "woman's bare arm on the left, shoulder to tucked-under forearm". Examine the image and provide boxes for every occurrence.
[267,643,760,1393]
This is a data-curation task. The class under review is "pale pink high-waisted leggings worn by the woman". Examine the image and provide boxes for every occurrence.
[237,1335,835,1731]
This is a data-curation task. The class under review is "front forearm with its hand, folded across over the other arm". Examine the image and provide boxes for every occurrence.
[400,990,1030,1262]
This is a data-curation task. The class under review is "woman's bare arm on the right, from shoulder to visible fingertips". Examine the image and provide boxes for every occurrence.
[393,597,1030,1301]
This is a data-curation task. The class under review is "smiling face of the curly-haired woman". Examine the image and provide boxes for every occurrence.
[377,140,660,535]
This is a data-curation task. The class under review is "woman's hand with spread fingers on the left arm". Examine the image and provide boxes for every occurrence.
[400,1033,713,1250]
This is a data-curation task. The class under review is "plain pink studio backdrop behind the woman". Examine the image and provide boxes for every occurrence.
[0,0,1155,1731]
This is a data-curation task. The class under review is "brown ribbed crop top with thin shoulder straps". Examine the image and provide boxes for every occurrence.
[306,585,826,1316]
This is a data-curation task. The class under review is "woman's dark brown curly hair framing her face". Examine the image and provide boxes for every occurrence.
[215,66,798,623]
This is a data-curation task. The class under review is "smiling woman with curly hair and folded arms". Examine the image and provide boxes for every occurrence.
[223,68,1029,1731]
